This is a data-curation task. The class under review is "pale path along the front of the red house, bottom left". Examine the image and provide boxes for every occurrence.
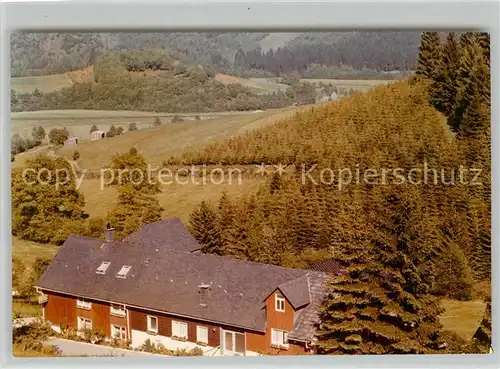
[44,338,168,357]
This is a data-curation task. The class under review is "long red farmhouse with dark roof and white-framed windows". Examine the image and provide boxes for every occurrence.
[36,218,336,355]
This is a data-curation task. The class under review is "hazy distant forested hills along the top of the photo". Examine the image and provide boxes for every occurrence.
[11,32,419,79]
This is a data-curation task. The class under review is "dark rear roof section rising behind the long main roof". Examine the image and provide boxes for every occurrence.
[123,218,200,251]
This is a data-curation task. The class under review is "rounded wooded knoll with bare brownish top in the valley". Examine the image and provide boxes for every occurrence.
[11,50,316,113]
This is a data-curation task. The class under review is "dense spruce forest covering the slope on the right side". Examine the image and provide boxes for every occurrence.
[187,32,491,354]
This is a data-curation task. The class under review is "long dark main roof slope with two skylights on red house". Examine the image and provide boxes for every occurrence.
[38,236,316,337]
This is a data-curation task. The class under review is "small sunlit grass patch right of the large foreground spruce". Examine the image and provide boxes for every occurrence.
[439,299,486,340]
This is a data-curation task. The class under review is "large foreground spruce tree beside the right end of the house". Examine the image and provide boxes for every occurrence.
[319,185,440,354]
